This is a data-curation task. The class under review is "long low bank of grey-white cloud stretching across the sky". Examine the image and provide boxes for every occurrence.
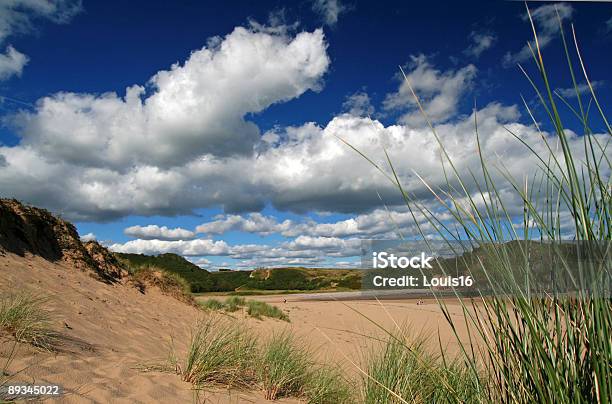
[0,95,604,223]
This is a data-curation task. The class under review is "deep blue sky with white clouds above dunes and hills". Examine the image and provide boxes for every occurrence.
[0,0,612,268]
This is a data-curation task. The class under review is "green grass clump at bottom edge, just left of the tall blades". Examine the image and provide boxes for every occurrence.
[362,331,482,404]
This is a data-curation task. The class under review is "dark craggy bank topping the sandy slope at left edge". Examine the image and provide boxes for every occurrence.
[0,199,125,282]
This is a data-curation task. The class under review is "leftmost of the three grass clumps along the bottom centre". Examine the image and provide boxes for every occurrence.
[175,317,257,387]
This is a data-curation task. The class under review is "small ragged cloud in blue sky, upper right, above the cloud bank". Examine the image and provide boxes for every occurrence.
[384,55,477,125]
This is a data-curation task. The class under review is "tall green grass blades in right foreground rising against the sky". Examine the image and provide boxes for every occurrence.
[349,5,612,403]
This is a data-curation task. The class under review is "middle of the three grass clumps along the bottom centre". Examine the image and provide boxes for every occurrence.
[258,331,351,403]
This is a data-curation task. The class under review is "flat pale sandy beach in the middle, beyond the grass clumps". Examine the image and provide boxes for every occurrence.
[199,294,468,373]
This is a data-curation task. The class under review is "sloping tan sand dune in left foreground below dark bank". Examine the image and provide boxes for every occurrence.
[0,253,304,403]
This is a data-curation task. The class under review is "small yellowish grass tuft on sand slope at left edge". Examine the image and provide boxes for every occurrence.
[0,292,58,350]
